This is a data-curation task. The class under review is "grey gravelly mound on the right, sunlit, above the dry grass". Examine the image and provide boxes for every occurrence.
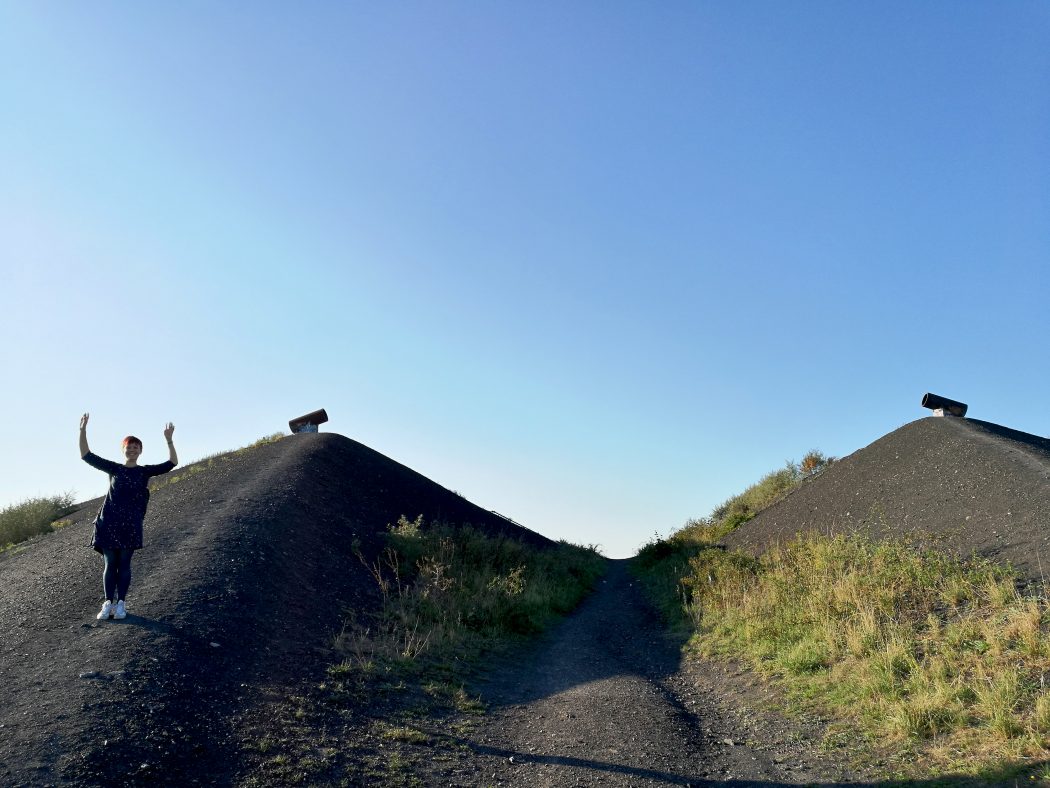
[726,417,1050,582]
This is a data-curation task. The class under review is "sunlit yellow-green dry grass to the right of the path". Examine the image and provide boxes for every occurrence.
[683,536,1050,772]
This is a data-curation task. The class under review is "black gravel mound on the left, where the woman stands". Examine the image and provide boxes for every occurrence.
[0,434,550,786]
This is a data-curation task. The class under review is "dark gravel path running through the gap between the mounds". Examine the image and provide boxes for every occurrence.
[428,561,848,786]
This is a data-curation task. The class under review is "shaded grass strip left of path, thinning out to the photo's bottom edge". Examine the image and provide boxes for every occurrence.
[320,517,608,786]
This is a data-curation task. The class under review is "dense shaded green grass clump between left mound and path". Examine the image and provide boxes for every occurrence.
[338,517,606,672]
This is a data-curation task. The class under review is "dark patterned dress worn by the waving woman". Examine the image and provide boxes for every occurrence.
[84,452,174,553]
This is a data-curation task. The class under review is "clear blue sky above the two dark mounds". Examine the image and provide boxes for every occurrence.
[0,0,1050,557]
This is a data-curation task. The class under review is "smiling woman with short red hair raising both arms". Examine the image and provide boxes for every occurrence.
[80,413,179,621]
